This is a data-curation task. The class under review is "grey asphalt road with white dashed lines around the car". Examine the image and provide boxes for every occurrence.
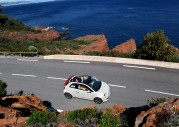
[0,58,179,110]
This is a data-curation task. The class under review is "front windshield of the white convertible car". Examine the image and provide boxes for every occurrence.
[88,77,101,91]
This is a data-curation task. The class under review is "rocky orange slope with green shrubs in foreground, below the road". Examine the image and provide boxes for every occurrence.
[0,94,179,127]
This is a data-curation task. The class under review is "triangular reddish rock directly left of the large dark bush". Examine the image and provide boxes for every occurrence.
[112,39,137,53]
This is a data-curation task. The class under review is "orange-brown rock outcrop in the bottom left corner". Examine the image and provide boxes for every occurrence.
[0,94,47,127]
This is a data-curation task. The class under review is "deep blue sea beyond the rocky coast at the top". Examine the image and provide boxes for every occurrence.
[0,0,179,48]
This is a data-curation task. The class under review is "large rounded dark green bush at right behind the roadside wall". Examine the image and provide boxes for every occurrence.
[134,30,177,61]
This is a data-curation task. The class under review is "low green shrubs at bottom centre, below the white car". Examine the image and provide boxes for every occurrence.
[66,108,127,127]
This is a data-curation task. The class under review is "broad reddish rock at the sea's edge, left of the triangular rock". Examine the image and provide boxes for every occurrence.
[75,34,109,54]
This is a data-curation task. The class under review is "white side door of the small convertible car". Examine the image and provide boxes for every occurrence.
[78,84,94,100]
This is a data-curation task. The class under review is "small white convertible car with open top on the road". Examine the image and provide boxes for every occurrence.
[63,75,111,104]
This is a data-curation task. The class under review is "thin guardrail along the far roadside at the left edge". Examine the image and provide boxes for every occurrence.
[0,52,38,57]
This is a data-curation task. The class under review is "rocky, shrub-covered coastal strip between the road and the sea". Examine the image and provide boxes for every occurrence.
[0,14,179,62]
